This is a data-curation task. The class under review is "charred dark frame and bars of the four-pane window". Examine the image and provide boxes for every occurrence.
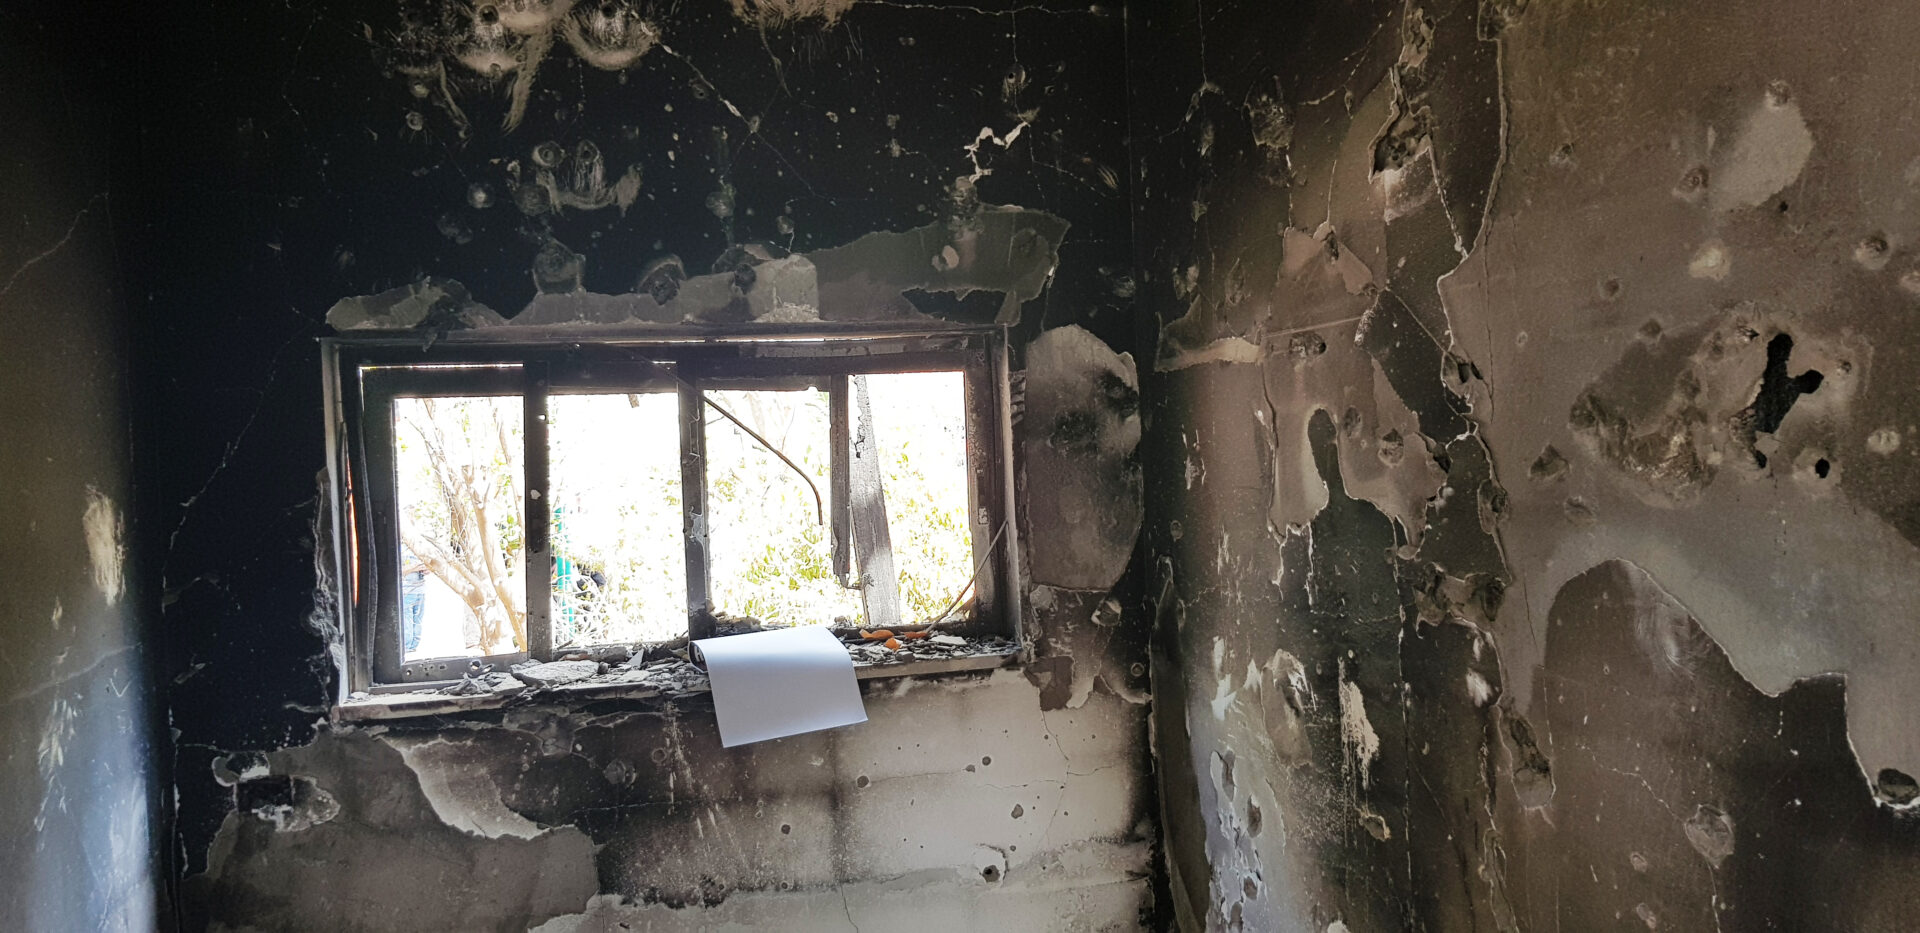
[321,324,1021,695]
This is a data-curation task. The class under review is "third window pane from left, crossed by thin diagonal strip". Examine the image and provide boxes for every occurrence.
[705,390,860,626]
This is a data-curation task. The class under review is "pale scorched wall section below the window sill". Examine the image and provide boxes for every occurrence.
[194,672,1154,931]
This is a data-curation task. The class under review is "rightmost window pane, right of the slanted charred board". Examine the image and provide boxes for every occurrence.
[866,372,973,622]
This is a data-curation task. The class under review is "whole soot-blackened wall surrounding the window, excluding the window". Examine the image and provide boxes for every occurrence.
[134,0,1158,929]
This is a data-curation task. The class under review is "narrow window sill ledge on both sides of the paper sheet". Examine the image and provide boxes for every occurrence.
[334,637,1021,722]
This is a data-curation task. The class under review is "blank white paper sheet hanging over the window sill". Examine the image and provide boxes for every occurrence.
[695,626,866,749]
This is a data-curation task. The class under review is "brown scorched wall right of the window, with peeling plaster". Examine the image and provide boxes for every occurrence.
[1129,0,1920,931]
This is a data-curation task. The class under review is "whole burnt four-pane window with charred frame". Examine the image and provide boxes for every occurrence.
[326,328,1018,689]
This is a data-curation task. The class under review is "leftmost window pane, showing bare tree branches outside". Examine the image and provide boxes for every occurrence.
[394,395,526,660]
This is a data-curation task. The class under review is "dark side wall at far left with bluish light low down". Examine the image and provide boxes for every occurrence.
[0,10,161,931]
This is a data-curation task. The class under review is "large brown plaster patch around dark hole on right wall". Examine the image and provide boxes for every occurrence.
[1446,0,1920,774]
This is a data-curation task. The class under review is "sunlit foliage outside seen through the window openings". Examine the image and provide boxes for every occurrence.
[397,374,973,647]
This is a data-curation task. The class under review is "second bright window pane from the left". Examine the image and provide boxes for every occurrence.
[547,392,687,649]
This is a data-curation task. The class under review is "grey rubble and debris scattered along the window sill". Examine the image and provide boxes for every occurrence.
[334,632,1020,722]
